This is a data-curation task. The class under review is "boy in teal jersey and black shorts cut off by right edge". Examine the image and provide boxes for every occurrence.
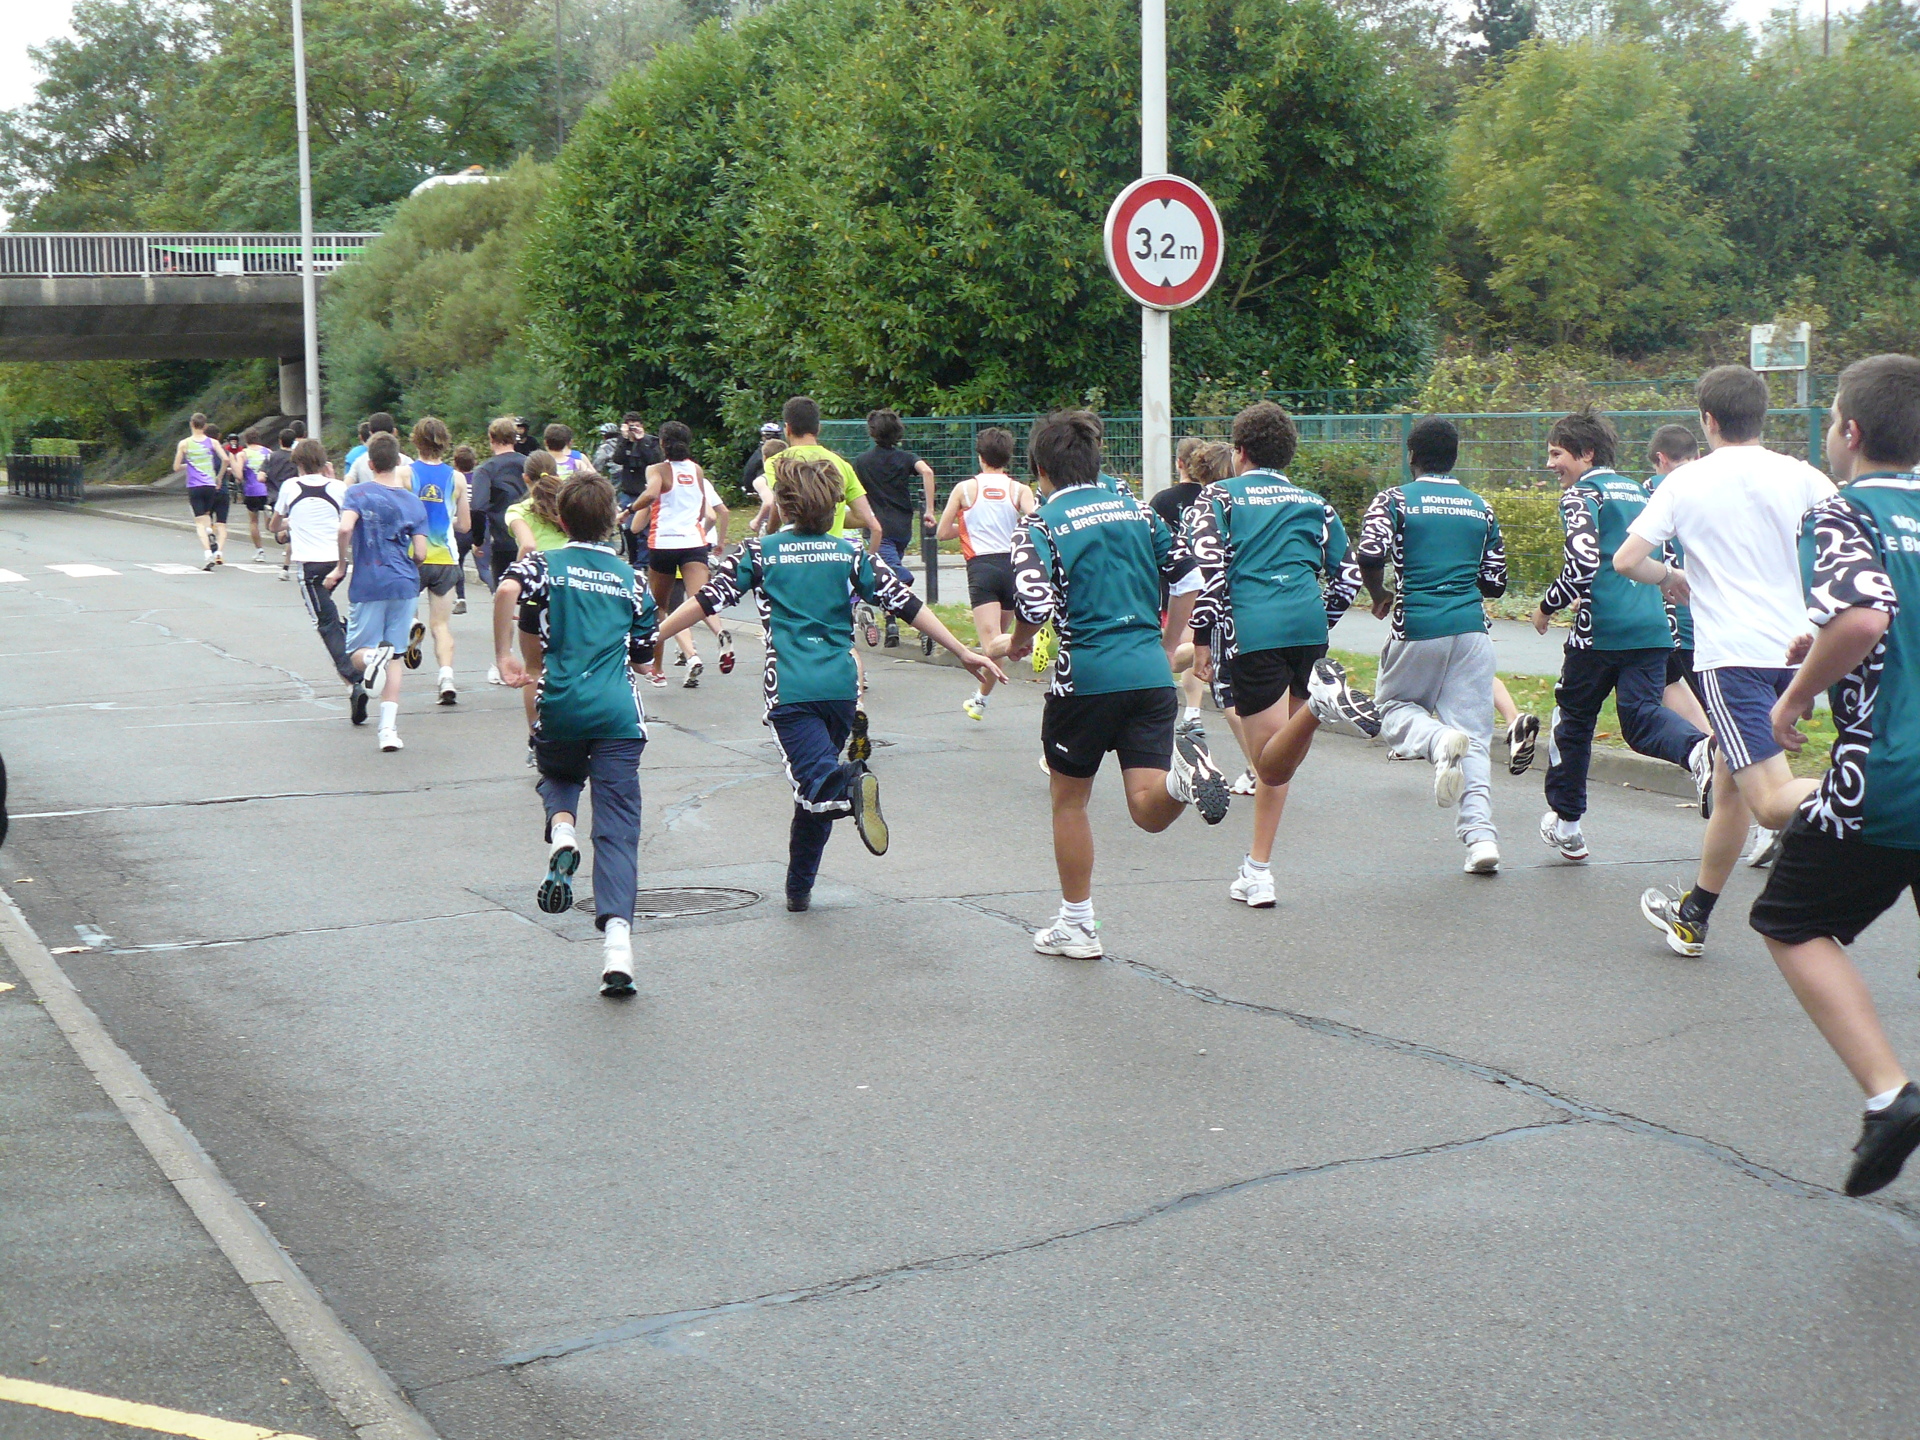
[1751,355,1920,1196]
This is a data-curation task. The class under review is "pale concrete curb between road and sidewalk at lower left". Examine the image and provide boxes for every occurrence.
[0,889,438,1440]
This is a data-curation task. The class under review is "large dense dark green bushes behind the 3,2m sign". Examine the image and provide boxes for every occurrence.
[528,0,1440,428]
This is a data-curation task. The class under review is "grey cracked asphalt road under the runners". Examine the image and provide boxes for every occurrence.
[0,509,1920,1440]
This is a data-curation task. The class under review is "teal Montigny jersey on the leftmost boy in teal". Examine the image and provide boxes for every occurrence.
[503,541,659,739]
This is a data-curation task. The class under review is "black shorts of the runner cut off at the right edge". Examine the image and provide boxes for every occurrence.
[1747,816,1920,945]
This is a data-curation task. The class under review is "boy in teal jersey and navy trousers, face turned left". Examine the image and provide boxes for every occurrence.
[1534,407,1713,864]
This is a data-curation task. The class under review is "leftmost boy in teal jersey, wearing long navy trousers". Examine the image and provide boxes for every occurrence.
[493,474,655,995]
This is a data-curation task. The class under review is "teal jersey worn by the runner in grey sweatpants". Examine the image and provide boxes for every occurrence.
[1354,474,1507,639]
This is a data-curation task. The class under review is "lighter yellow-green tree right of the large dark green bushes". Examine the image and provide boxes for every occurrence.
[1453,40,1726,348]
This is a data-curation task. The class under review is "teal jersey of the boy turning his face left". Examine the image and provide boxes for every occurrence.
[1540,470,1674,651]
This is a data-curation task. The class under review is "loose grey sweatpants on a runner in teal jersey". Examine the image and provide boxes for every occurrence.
[1373,630,1500,845]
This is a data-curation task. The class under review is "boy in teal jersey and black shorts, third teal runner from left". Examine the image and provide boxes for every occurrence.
[1008,411,1227,960]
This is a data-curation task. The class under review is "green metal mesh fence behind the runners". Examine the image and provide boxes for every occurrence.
[820,407,1826,595]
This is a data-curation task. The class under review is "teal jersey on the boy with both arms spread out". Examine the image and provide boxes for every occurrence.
[699,530,920,708]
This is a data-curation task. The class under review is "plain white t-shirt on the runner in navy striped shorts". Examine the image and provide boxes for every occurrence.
[1609,445,1834,670]
